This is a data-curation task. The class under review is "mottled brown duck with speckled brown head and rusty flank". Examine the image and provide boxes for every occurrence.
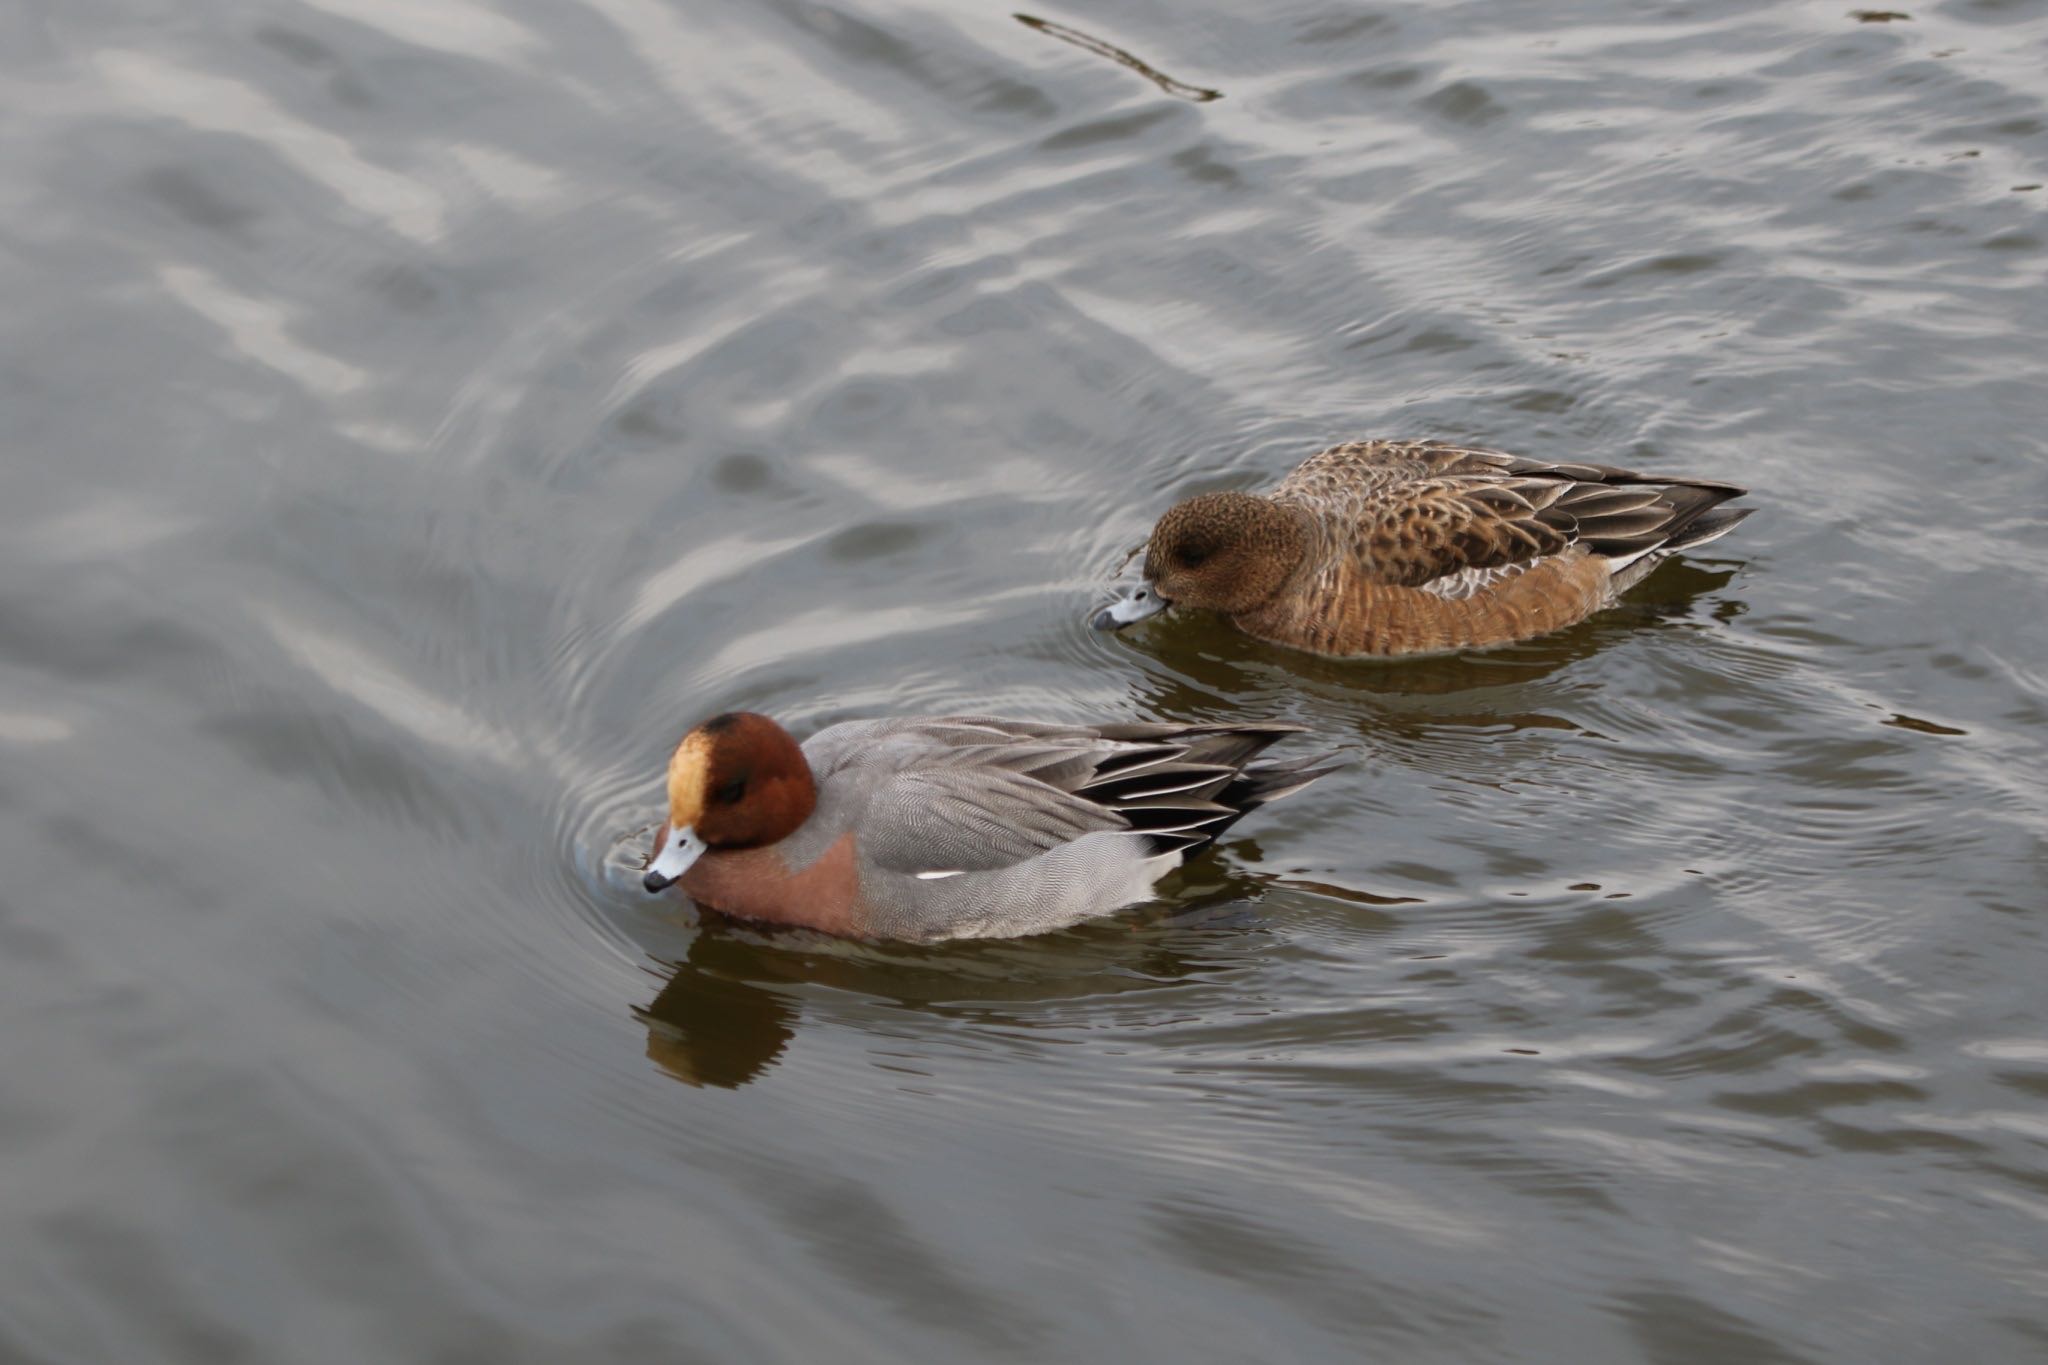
[1092,440,1753,657]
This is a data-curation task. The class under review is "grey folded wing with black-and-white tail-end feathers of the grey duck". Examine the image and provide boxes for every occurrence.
[839,716,1329,876]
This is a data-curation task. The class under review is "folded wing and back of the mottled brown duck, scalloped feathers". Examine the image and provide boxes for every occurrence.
[1274,442,1747,598]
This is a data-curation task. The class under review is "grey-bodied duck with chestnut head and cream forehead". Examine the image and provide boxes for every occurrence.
[643,712,1337,941]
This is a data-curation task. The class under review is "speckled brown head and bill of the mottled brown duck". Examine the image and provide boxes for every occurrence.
[1090,493,1307,630]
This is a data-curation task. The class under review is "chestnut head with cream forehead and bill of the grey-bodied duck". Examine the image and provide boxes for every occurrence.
[645,710,817,890]
